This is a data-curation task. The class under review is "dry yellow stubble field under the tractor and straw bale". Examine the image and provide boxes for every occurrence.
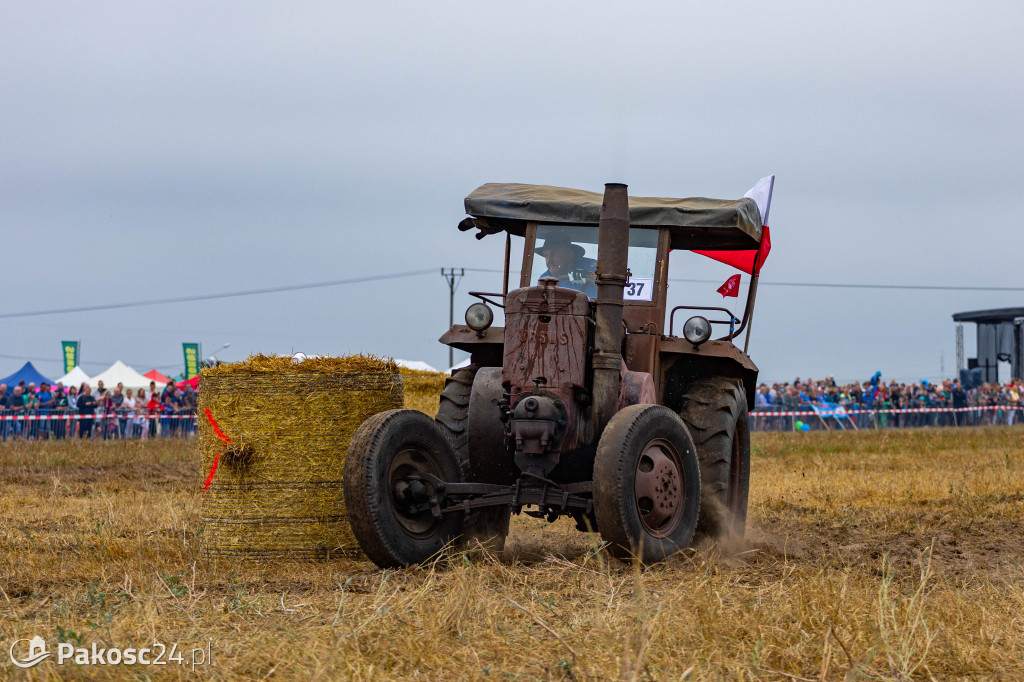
[0,427,1024,680]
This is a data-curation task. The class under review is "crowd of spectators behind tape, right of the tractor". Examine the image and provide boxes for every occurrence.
[755,372,1024,426]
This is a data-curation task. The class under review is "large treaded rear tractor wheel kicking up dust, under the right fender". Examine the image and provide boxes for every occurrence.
[679,377,751,538]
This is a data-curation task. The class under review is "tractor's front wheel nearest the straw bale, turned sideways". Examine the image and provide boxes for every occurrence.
[344,410,465,568]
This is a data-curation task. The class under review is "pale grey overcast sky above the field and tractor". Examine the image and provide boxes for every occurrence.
[0,1,1024,380]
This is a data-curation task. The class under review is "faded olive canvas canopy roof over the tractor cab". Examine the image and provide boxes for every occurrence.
[459,182,762,250]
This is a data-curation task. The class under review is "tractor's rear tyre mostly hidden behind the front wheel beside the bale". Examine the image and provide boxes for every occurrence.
[436,365,512,552]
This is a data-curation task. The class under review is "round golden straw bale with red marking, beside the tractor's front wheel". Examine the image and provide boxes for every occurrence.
[199,355,402,558]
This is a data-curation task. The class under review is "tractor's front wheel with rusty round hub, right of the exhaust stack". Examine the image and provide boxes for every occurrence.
[594,404,700,563]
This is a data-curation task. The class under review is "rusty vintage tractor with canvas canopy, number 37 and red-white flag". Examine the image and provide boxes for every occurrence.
[344,178,771,567]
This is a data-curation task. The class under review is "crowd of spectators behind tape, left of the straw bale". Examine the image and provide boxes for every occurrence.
[0,381,197,440]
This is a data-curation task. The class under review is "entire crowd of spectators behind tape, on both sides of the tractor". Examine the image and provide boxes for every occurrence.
[0,372,1024,440]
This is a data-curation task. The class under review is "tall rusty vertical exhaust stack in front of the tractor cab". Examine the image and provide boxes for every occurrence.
[593,182,630,432]
